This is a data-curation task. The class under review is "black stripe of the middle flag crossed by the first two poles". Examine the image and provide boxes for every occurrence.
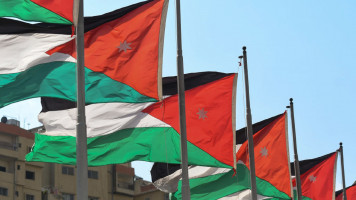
[41,72,231,112]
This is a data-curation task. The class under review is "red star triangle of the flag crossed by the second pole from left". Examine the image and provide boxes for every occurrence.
[143,74,237,167]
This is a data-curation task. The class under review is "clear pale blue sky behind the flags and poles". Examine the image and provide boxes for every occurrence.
[0,0,356,189]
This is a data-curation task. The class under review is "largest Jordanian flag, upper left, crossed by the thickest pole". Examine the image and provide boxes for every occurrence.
[0,0,167,107]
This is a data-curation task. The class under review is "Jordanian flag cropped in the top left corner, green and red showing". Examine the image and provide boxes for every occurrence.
[0,0,74,24]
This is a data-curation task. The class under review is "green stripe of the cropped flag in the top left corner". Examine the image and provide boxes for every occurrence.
[0,0,72,24]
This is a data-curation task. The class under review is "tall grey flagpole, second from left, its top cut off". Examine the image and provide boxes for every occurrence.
[176,0,190,200]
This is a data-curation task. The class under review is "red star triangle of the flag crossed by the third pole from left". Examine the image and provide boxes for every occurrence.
[236,112,292,196]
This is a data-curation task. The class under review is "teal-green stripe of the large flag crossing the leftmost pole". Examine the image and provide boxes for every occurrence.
[0,61,156,108]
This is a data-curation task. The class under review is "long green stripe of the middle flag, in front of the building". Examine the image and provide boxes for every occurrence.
[26,127,228,167]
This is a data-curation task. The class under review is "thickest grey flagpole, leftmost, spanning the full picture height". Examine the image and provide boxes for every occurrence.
[75,0,88,200]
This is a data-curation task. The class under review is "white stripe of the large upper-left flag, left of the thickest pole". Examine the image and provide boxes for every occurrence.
[0,33,75,74]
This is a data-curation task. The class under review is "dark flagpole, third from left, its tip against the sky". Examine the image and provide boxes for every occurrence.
[242,46,257,200]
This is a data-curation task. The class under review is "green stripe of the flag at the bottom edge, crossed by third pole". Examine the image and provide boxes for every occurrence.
[171,164,291,200]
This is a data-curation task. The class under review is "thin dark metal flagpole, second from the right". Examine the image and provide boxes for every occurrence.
[287,98,302,200]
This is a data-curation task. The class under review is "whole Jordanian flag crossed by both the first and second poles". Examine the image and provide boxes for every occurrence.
[26,72,237,168]
